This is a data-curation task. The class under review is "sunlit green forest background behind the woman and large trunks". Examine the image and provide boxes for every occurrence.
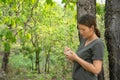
[0,0,113,80]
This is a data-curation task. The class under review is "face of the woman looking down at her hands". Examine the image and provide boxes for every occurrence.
[78,24,94,39]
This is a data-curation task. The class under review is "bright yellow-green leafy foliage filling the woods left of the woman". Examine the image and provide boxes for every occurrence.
[0,0,78,80]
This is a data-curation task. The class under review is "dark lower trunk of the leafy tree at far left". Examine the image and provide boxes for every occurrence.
[1,52,10,72]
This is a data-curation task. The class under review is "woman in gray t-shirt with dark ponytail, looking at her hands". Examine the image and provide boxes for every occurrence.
[64,14,104,80]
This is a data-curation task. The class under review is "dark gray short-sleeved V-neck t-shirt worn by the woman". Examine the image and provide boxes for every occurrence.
[72,39,104,80]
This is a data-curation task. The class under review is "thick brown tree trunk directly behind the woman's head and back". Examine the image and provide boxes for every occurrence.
[77,0,104,80]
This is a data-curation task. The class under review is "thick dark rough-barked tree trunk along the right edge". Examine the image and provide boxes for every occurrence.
[105,0,120,80]
